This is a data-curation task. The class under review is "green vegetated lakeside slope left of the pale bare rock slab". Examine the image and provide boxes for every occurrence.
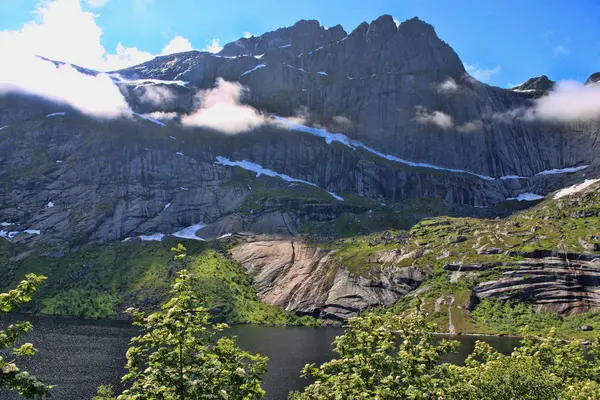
[0,240,317,325]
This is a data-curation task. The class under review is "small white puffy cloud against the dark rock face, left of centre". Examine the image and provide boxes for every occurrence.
[181,78,266,134]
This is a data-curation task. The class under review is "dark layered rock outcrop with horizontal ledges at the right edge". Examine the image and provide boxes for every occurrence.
[458,251,600,315]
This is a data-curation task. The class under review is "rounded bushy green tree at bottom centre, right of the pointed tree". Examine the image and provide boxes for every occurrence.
[290,314,457,400]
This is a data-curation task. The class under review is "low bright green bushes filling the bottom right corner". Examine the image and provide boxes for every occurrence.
[443,331,600,400]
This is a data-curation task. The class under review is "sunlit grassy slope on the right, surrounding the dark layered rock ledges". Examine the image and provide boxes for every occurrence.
[318,185,600,338]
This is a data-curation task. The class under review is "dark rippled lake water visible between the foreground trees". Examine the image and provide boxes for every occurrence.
[0,317,518,400]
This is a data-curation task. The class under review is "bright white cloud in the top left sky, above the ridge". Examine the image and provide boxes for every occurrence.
[0,0,191,71]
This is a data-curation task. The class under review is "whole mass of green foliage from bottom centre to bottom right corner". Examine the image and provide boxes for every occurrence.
[290,314,600,400]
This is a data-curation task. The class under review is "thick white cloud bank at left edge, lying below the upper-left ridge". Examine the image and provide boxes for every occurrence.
[0,55,129,118]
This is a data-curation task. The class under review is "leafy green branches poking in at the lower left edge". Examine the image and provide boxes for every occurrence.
[0,274,52,399]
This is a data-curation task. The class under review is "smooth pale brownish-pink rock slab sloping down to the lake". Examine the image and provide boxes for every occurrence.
[231,240,427,320]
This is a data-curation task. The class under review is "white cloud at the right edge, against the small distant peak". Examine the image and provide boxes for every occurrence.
[525,81,600,121]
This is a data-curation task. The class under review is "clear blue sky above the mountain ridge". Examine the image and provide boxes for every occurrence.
[0,0,600,87]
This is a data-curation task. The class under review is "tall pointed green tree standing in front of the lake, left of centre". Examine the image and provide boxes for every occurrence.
[96,245,267,400]
